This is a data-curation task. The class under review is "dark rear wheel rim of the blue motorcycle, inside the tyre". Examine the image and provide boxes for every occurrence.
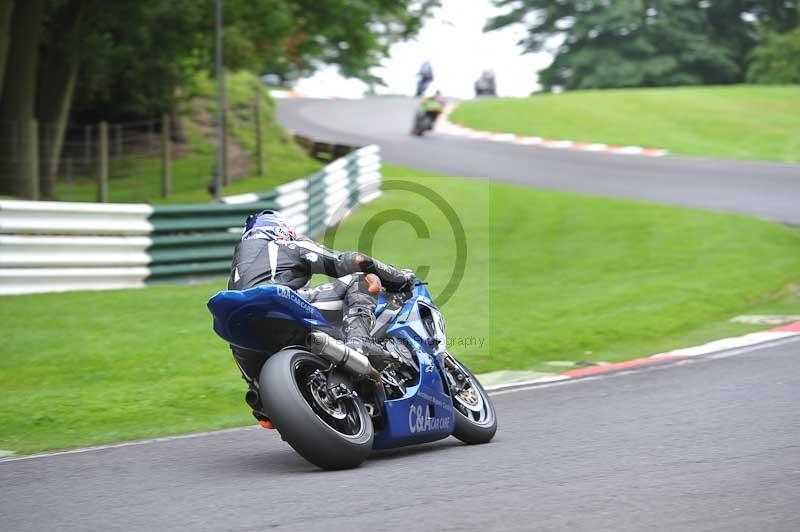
[292,360,366,439]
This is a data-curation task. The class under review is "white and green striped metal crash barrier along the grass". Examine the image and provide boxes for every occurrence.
[0,146,381,295]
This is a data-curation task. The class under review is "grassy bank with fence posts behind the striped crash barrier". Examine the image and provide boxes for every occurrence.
[51,72,322,203]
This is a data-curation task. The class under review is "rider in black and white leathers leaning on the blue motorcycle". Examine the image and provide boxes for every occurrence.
[228,211,415,410]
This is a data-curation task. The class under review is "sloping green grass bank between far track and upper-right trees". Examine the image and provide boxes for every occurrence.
[452,85,800,162]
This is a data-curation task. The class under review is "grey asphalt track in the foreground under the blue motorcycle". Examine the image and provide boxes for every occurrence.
[0,339,800,532]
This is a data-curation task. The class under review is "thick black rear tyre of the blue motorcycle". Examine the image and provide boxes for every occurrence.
[259,349,374,469]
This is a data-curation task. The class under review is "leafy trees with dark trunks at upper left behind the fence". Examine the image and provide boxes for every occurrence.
[0,0,438,198]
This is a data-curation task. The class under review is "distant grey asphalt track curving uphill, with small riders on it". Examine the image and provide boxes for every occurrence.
[278,98,800,225]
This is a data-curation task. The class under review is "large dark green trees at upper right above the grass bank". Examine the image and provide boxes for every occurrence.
[486,0,798,90]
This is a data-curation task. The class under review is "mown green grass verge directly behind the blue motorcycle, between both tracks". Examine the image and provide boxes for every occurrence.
[0,167,800,453]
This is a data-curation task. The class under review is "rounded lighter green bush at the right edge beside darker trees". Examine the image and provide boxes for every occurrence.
[747,28,800,85]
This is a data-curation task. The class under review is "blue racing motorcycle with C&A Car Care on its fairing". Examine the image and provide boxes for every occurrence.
[208,282,497,469]
